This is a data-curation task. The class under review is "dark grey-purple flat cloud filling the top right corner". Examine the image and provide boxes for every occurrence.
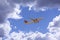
[33,0,60,10]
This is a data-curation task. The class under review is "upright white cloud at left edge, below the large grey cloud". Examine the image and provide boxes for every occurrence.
[0,21,11,37]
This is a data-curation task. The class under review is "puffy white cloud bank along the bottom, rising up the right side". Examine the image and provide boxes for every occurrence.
[2,15,60,40]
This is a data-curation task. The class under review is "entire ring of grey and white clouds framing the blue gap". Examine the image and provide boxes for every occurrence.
[0,0,60,40]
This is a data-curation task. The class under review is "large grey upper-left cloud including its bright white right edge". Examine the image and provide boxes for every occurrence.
[0,0,22,23]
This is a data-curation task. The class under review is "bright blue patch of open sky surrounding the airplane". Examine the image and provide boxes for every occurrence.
[10,7,60,33]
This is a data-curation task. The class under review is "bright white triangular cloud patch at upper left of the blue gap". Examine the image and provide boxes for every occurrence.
[8,4,22,19]
